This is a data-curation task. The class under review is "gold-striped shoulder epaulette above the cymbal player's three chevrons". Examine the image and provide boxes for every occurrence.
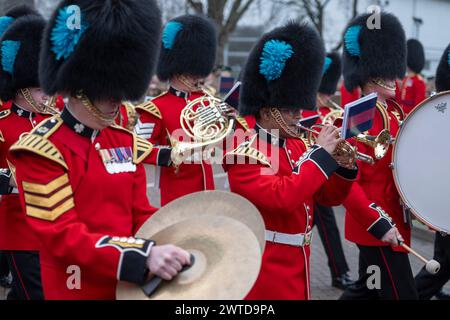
[10,116,68,169]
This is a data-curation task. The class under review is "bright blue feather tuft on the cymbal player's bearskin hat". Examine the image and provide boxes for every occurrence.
[50,7,88,60]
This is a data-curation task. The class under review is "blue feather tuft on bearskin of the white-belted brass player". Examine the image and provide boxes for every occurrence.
[259,40,294,81]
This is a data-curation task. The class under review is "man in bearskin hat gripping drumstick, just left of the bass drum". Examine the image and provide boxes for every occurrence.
[341,12,417,300]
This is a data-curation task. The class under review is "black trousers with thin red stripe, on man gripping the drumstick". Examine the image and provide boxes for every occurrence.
[339,245,418,300]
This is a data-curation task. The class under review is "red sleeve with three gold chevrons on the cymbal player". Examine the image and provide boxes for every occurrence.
[12,153,153,283]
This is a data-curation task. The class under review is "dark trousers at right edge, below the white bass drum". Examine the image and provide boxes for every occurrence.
[416,232,450,300]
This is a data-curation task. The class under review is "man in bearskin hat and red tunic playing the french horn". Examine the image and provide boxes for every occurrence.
[135,15,217,205]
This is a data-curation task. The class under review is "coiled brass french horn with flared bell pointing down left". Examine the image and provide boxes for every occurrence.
[170,92,235,167]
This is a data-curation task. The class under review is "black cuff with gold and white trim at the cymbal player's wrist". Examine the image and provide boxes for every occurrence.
[95,236,155,284]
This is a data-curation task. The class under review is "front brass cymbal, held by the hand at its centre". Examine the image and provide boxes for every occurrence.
[116,215,262,300]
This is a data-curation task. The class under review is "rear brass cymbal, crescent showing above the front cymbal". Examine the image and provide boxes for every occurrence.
[136,190,266,252]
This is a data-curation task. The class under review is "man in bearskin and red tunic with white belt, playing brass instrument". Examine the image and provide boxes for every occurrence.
[223,22,357,300]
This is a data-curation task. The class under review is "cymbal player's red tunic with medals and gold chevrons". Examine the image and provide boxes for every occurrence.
[9,111,167,299]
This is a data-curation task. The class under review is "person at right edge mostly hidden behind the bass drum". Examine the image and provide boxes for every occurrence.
[416,45,450,300]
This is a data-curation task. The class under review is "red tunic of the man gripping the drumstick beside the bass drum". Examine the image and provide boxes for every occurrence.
[344,101,411,251]
